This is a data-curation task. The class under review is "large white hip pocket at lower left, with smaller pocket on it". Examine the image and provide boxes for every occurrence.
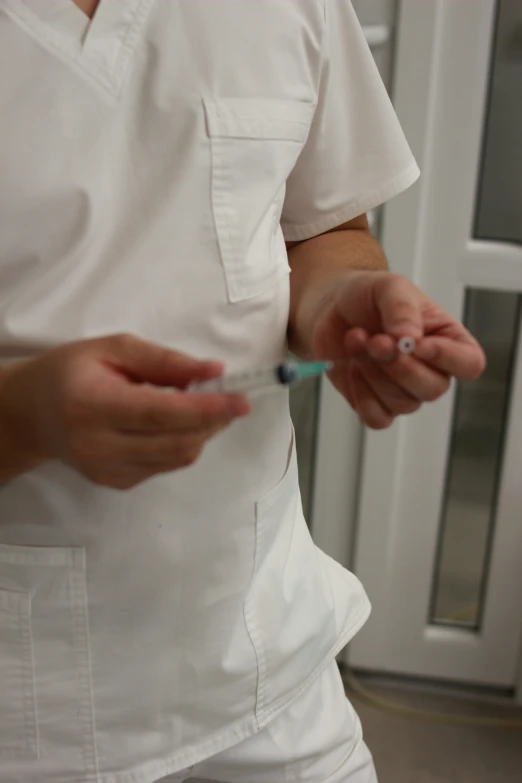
[0,544,96,779]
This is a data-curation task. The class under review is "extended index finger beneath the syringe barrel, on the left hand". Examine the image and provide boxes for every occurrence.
[105,386,250,433]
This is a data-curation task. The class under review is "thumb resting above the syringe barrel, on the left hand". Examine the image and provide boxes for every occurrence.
[101,335,223,389]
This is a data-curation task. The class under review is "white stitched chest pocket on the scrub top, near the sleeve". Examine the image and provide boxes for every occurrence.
[204,98,314,302]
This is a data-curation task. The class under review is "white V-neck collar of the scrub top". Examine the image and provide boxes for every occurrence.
[0,0,154,98]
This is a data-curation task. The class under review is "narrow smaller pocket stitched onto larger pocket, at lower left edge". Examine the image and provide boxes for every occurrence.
[0,590,38,760]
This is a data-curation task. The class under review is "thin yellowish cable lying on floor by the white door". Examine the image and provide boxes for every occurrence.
[341,666,522,731]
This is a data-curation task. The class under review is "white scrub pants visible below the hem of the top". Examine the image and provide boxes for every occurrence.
[156,661,377,783]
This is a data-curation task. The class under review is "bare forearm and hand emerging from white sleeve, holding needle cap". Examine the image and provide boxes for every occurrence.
[282,216,485,429]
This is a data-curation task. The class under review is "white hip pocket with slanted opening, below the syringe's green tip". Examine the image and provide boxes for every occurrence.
[245,432,337,718]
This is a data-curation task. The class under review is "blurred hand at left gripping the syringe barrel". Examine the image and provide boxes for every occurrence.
[1,335,250,489]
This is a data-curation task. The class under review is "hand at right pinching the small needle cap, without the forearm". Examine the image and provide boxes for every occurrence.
[313,271,486,429]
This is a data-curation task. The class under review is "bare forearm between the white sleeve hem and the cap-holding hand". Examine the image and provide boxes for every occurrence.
[288,218,388,358]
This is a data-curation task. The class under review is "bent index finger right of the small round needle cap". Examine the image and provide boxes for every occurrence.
[415,336,486,381]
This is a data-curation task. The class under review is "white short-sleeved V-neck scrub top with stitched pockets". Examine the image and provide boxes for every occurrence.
[0,0,418,783]
